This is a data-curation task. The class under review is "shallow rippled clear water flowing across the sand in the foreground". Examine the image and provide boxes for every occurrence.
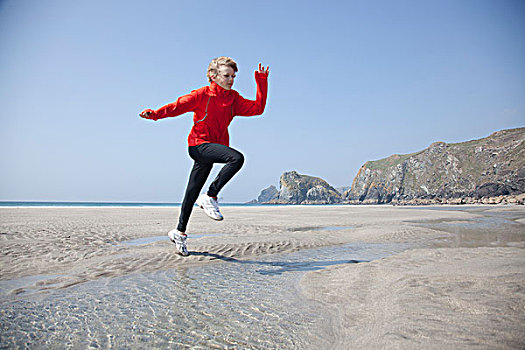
[0,244,408,349]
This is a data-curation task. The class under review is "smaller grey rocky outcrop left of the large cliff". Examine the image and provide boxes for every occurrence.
[256,171,342,204]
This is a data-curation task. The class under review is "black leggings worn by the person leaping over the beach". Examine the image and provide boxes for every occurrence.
[177,143,244,232]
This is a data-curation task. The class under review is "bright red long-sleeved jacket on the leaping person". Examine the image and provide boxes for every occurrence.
[142,71,268,146]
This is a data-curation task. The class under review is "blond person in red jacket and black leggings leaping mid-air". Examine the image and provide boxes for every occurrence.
[140,57,269,256]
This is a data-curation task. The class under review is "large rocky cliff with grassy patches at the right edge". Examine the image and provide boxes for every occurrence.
[343,128,525,204]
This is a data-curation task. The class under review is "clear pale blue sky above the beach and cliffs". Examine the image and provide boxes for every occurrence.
[0,0,525,202]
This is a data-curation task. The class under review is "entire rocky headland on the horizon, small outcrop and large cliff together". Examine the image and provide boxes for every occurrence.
[252,128,525,205]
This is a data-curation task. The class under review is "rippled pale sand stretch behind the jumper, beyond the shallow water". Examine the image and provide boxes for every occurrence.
[0,207,469,292]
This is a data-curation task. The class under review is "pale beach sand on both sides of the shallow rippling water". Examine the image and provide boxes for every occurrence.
[0,206,525,349]
